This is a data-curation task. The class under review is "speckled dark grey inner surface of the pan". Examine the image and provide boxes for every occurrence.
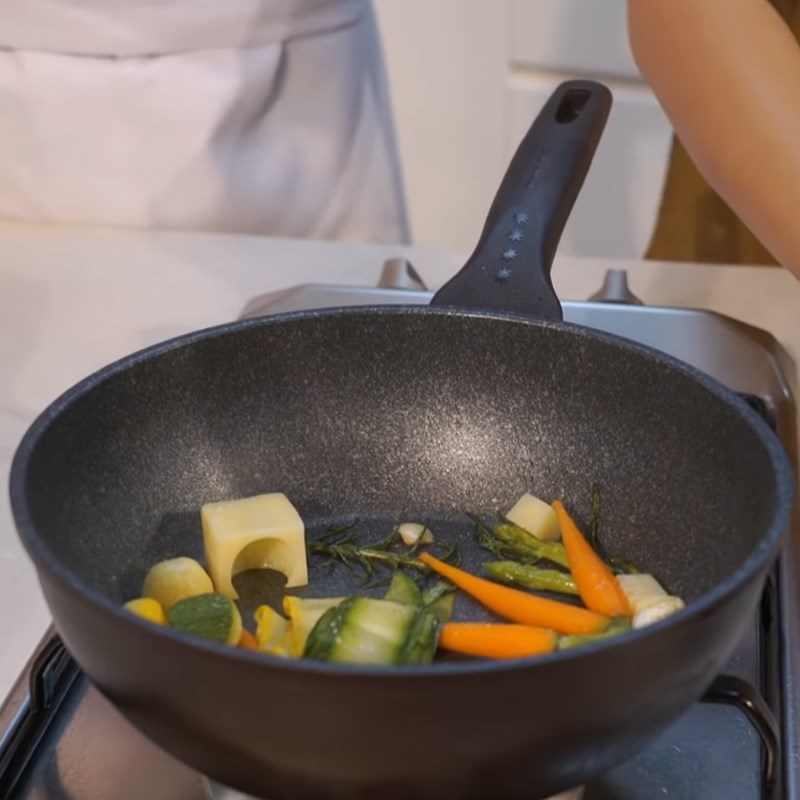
[20,309,776,601]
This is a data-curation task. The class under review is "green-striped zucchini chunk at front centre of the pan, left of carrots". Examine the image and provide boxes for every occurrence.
[303,597,439,664]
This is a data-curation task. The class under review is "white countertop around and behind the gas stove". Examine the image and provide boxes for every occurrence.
[0,225,800,703]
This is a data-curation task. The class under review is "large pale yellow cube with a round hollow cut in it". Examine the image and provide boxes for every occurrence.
[201,492,308,600]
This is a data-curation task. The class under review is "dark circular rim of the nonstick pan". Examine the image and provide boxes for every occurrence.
[9,304,795,680]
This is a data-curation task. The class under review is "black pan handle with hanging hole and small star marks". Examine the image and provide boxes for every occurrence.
[431,81,611,319]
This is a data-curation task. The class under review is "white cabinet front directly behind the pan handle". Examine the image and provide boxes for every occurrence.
[375,0,671,257]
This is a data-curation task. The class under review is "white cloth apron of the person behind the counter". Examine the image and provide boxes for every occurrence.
[0,0,408,242]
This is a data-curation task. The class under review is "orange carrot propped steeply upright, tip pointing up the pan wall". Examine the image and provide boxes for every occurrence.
[553,500,632,617]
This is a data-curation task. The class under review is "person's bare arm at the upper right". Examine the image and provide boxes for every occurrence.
[628,0,800,278]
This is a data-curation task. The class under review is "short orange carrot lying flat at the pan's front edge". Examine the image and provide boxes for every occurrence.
[439,622,558,658]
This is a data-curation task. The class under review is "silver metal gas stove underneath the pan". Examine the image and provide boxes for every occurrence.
[0,259,800,800]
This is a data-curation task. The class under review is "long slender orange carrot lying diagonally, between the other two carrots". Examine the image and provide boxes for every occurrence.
[419,553,609,635]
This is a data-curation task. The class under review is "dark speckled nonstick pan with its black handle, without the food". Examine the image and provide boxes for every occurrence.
[11,82,792,800]
